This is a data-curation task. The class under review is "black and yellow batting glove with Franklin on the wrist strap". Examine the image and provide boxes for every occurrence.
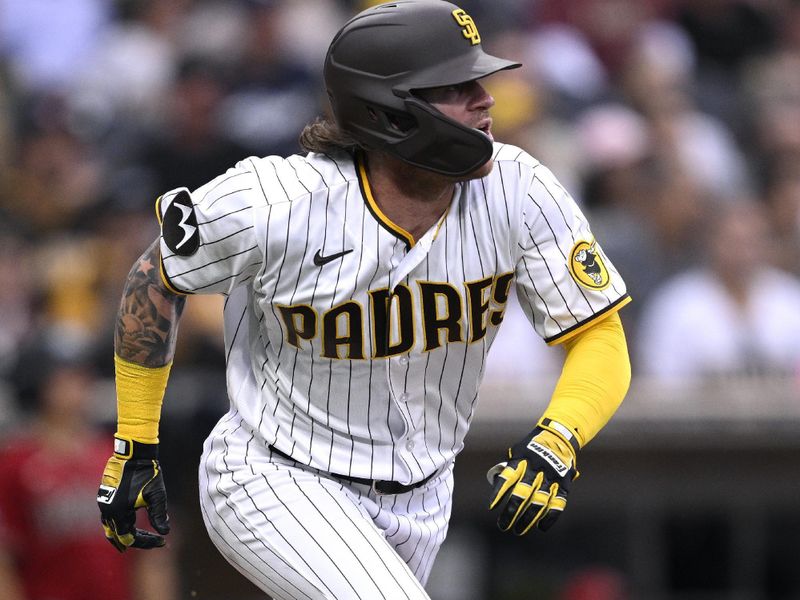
[486,425,578,535]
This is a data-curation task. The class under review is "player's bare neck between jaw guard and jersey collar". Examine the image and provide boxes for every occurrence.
[367,152,456,239]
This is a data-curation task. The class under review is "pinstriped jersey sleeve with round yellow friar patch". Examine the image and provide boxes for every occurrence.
[516,164,630,345]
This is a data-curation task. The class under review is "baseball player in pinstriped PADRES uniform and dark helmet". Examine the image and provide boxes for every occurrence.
[98,0,630,600]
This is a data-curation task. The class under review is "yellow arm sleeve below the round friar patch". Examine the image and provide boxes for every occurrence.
[543,313,631,447]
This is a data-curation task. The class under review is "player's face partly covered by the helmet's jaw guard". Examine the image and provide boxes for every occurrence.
[418,81,494,179]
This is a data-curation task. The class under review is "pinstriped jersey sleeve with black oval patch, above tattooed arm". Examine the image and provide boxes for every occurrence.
[156,163,263,294]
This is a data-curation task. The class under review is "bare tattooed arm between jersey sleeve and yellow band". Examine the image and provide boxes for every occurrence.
[114,240,186,367]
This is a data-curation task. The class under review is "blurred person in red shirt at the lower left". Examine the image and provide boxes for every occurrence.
[0,344,176,600]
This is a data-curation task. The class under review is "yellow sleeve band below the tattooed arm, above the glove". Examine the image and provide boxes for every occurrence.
[114,354,172,444]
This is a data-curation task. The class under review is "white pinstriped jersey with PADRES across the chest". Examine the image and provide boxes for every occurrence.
[158,144,629,483]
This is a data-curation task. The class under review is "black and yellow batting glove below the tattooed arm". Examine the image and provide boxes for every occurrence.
[97,438,169,552]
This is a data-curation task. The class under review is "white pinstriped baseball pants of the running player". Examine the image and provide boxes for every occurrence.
[199,411,453,600]
